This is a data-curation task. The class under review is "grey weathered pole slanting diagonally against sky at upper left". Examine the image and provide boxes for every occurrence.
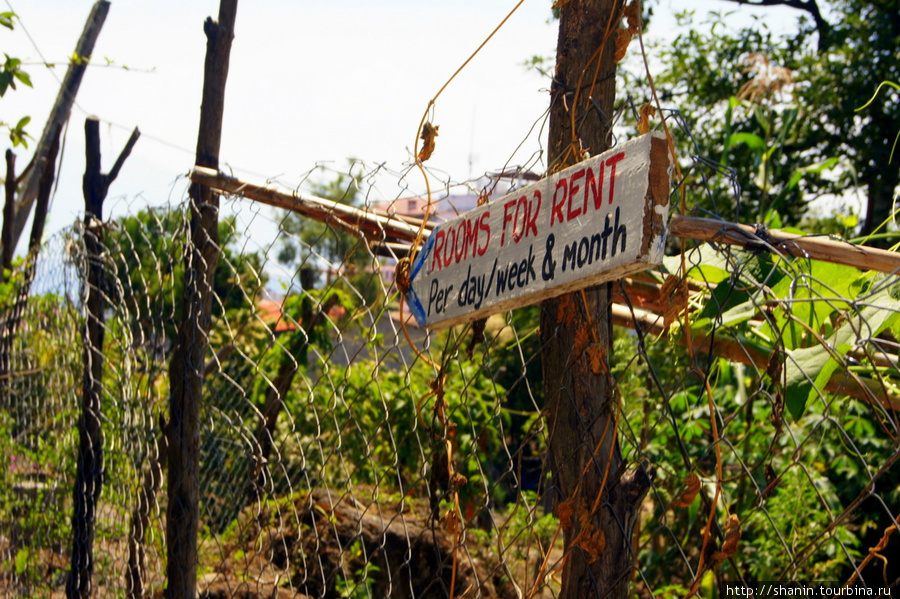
[9,0,109,251]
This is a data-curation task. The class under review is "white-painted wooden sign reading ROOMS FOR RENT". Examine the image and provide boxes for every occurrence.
[406,133,670,329]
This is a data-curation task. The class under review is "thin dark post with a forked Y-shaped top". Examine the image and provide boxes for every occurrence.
[67,117,140,599]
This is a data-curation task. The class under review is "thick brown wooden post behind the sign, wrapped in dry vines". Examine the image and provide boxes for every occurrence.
[541,0,649,599]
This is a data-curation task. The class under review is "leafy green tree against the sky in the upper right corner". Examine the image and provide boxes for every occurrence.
[636,0,900,233]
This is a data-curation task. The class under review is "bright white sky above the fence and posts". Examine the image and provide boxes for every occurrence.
[0,0,800,255]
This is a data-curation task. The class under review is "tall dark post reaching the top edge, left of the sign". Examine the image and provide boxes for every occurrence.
[166,0,237,599]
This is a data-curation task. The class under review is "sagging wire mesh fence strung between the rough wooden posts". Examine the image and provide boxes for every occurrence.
[0,137,900,598]
